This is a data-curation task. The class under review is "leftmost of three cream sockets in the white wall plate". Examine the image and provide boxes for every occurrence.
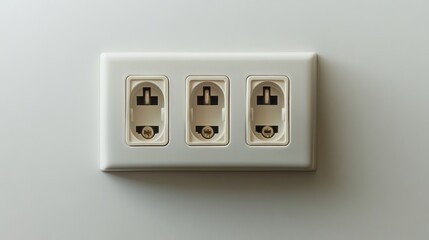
[125,75,168,146]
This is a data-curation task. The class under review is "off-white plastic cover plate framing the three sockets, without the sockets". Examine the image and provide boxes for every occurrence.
[100,53,316,171]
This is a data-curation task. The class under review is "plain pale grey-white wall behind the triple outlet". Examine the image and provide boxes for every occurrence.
[0,0,429,240]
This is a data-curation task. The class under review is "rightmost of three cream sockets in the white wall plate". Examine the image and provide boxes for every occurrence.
[246,76,289,146]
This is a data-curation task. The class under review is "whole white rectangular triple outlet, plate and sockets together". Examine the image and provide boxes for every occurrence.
[100,53,316,171]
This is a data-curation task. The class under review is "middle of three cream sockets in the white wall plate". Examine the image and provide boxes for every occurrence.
[186,76,229,145]
